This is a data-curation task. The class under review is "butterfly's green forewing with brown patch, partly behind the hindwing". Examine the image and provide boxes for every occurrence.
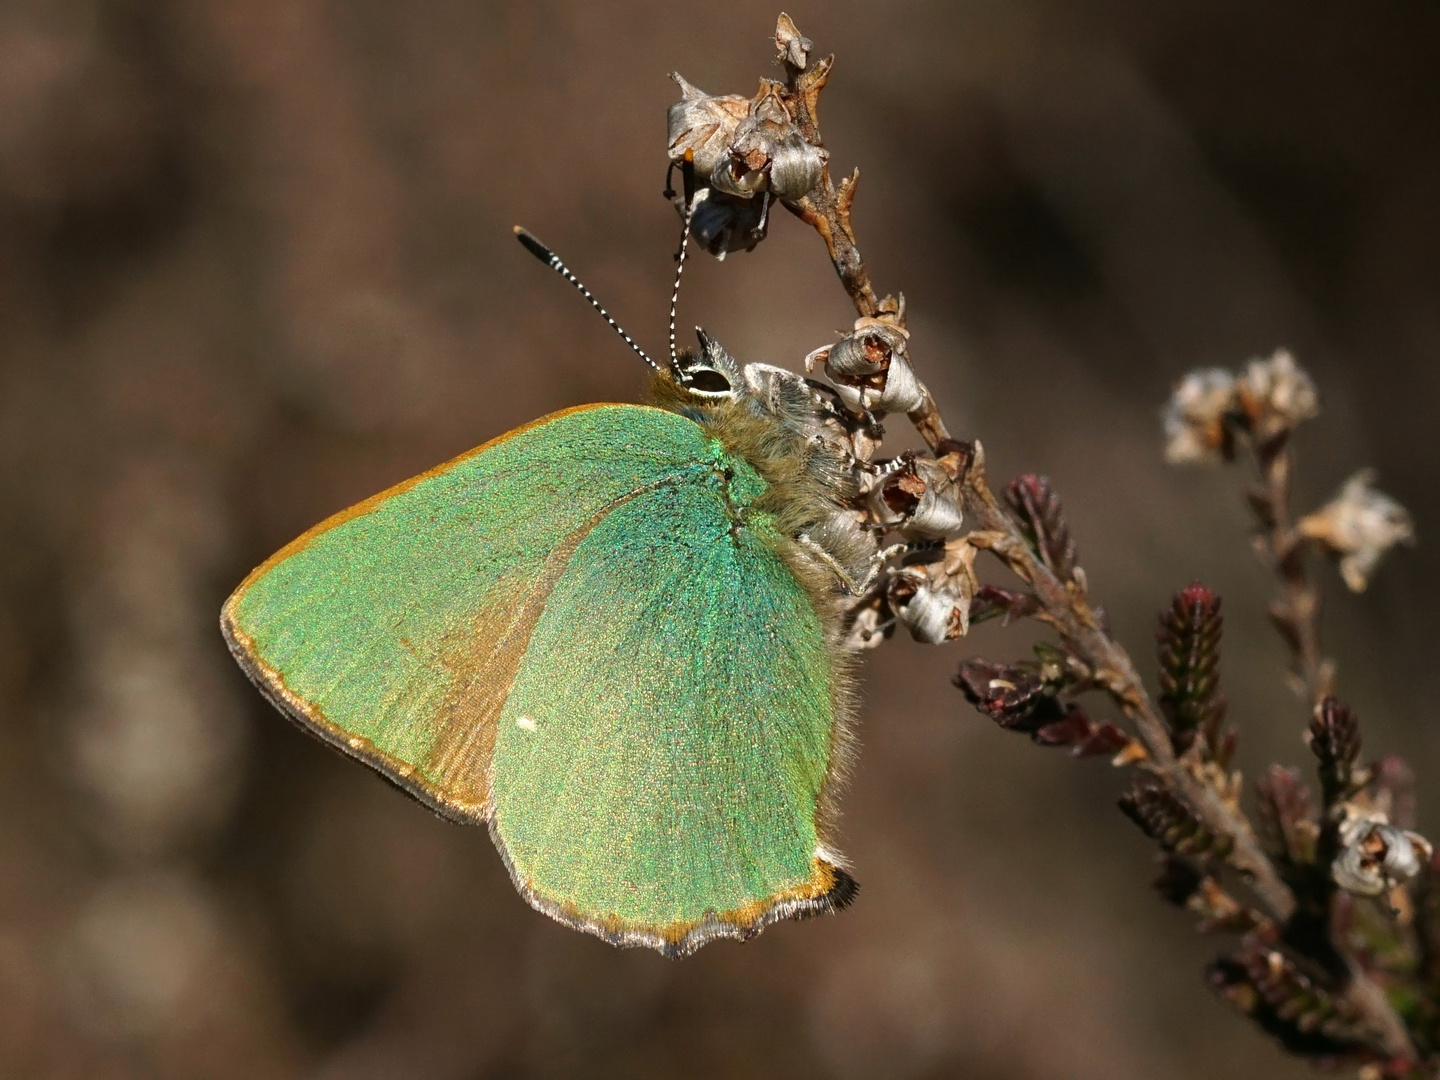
[220,405,713,821]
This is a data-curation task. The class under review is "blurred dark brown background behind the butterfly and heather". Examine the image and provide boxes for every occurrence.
[0,0,1440,1080]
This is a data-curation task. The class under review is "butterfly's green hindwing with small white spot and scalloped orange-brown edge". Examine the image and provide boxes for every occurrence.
[491,472,854,953]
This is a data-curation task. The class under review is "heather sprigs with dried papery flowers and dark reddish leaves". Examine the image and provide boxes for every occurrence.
[668,14,1440,1077]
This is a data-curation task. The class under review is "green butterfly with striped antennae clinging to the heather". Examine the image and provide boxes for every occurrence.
[220,222,876,955]
